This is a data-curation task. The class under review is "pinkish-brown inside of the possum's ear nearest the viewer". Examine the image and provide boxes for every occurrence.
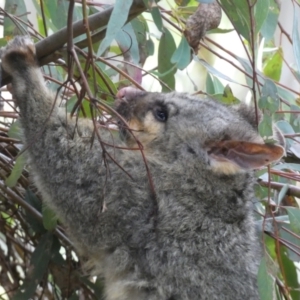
[208,141,285,169]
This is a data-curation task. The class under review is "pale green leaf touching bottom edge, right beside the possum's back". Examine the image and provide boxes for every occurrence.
[257,257,274,300]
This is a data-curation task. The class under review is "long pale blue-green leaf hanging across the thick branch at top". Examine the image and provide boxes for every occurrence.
[97,0,133,56]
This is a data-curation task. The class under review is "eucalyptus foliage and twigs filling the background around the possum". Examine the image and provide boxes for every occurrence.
[0,0,300,300]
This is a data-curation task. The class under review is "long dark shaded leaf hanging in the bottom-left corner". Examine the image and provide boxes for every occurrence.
[12,232,53,300]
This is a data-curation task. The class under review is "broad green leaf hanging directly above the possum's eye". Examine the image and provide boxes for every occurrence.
[157,29,177,92]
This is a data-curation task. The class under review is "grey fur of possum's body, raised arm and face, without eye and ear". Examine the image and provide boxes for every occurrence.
[2,37,278,300]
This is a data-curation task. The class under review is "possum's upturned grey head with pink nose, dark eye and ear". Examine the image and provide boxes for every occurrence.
[116,87,284,174]
